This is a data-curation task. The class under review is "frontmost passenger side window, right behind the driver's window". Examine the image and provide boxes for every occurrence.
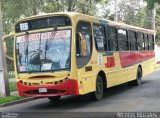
[93,24,107,51]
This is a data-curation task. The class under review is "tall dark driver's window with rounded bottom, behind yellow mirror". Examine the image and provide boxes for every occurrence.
[76,21,92,67]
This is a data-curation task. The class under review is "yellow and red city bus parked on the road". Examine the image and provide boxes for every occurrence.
[4,12,155,102]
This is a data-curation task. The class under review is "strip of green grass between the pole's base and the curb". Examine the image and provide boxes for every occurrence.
[0,95,23,104]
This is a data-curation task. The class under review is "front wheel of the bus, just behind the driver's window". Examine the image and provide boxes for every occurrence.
[92,76,104,100]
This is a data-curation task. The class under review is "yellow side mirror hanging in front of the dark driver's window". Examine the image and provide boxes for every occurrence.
[78,33,87,57]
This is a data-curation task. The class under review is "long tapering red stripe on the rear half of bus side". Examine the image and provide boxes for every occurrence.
[119,51,155,67]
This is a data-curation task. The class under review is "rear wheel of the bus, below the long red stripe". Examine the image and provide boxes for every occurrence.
[133,67,142,86]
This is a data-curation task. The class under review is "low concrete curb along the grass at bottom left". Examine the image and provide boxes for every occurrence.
[0,97,35,107]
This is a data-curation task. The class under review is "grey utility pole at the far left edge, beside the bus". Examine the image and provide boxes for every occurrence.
[0,0,10,97]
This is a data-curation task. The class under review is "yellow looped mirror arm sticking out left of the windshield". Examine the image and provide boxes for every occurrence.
[2,34,15,61]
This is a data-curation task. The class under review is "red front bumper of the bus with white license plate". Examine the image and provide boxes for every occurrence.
[17,79,79,98]
